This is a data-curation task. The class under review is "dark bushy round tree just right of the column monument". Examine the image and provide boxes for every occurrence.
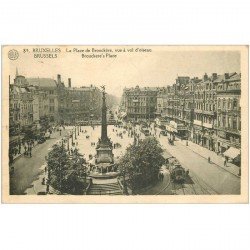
[119,137,164,190]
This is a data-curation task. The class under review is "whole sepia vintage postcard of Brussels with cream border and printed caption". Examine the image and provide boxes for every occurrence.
[2,45,249,203]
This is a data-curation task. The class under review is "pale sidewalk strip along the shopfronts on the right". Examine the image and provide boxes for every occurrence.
[176,139,240,178]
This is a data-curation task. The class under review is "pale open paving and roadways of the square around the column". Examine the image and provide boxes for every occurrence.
[10,121,240,195]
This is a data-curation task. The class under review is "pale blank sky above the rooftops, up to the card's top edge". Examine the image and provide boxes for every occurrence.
[6,46,241,97]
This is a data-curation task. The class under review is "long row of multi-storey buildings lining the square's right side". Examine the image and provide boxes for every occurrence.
[122,72,241,153]
